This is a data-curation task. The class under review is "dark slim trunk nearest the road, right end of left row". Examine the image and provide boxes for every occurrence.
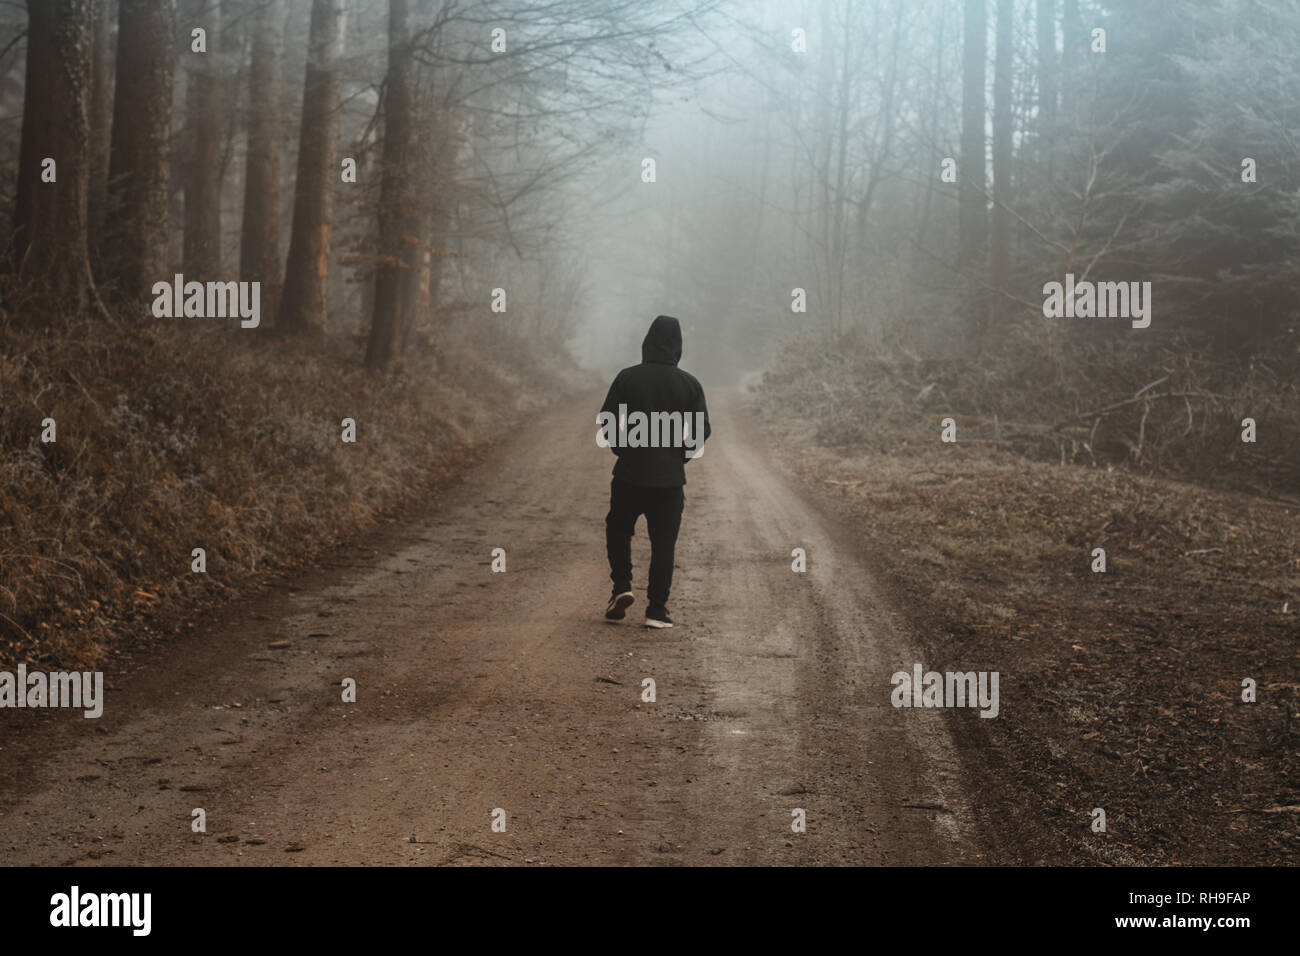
[365,0,411,368]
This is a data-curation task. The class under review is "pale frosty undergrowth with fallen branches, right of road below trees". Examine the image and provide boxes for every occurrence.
[758,334,1300,502]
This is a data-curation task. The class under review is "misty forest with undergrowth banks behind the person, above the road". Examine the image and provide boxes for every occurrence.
[0,0,1300,681]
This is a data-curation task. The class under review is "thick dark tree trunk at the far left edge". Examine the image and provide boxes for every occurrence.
[12,0,92,315]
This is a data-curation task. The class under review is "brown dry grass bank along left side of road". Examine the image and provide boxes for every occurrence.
[0,303,569,666]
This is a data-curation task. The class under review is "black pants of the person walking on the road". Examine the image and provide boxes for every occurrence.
[605,479,686,607]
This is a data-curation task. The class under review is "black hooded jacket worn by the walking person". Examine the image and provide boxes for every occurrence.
[601,315,712,488]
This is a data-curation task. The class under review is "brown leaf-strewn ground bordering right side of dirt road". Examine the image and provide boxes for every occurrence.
[766,403,1300,865]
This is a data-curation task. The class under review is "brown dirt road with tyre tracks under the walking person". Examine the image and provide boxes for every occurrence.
[0,397,989,865]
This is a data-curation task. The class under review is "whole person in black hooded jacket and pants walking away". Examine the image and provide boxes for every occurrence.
[597,315,712,627]
